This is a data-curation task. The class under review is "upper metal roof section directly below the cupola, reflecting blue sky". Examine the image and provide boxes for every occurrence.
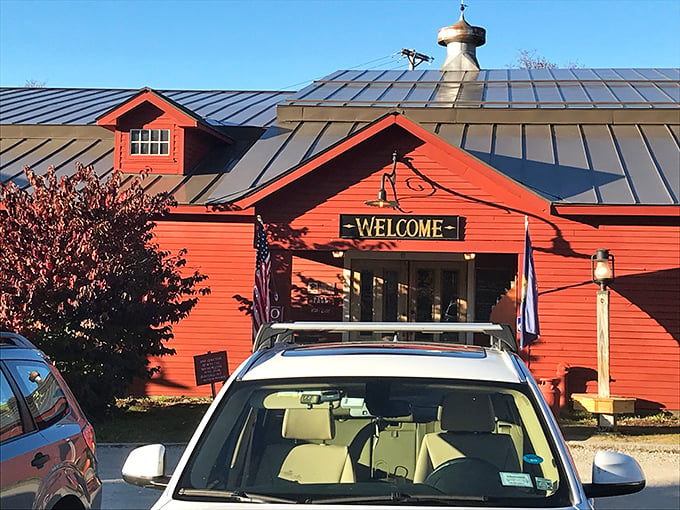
[285,69,680,108]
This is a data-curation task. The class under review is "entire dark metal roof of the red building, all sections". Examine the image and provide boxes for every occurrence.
[0,69,680,205]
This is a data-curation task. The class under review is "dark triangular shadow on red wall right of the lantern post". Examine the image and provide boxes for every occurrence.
[610,268,680,344]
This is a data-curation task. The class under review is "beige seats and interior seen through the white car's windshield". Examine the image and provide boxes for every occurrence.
[254,390,557,484]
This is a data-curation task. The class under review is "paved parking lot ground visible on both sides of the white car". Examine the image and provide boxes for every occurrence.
[97,441,680,510]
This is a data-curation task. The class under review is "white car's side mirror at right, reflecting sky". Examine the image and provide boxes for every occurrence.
[583,450,645,498]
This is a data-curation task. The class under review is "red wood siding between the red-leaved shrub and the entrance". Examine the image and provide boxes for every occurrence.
[135,218,255,396]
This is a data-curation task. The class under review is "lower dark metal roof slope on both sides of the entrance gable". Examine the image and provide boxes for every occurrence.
[207,119,680,205]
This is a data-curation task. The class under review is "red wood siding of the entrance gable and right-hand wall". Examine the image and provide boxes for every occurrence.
[258,130,680,409]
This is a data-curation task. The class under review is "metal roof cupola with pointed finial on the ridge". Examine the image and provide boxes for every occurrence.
[437,0,486,71]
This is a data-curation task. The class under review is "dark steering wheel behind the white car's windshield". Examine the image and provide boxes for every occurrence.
[423,457,503,495]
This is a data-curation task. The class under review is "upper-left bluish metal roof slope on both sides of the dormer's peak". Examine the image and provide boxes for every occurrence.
[0,88,291,127]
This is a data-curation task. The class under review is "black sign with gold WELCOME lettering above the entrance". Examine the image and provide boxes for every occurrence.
[340,214,460,241]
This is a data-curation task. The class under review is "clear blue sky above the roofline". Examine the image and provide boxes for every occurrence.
[0,0,680,90]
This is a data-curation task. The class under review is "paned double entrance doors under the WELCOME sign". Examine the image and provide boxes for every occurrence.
[350,259,467,342]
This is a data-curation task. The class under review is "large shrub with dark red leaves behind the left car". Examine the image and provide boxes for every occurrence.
[0,164,209,414]
